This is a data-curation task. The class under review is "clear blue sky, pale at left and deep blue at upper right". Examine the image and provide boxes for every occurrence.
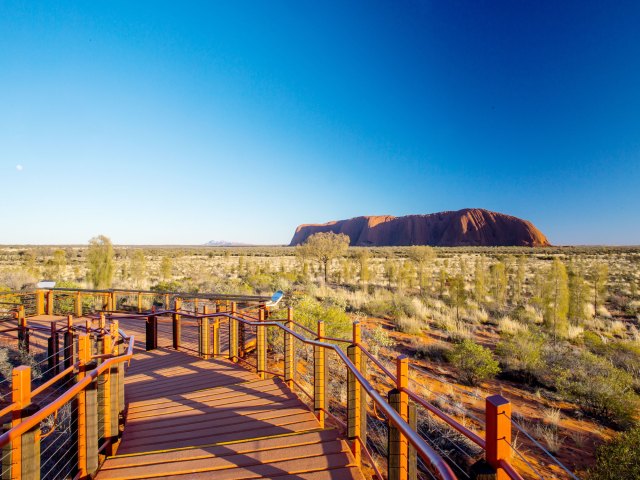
[0,0,640,244]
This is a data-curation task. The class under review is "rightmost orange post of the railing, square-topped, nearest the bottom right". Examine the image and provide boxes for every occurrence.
[485,395,511,480]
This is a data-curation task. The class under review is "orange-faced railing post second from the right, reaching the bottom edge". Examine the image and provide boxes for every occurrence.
[388,355,409,480]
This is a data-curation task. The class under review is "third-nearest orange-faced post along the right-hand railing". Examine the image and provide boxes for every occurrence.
[347,322,364,465]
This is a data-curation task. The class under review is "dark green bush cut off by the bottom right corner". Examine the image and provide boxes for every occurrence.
[588,427,640,480]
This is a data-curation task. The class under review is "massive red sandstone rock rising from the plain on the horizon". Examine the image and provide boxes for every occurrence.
[291,208,550,247]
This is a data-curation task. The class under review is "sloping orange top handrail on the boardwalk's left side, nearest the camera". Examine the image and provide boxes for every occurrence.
[0,335,135,448]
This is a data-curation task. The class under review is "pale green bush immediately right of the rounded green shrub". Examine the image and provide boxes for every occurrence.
[496,331,544,383]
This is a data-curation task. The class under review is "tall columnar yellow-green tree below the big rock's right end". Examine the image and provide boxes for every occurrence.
[543,258,569,341]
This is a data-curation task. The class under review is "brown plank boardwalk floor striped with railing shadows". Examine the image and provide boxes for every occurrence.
[96,327,363,480]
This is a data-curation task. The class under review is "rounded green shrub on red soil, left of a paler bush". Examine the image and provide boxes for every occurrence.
[447,340,500,385]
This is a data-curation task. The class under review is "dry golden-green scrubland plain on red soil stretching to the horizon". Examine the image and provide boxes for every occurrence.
[0,238,640,478]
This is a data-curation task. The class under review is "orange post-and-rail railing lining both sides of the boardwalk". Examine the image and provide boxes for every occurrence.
[0,289,544,479]
